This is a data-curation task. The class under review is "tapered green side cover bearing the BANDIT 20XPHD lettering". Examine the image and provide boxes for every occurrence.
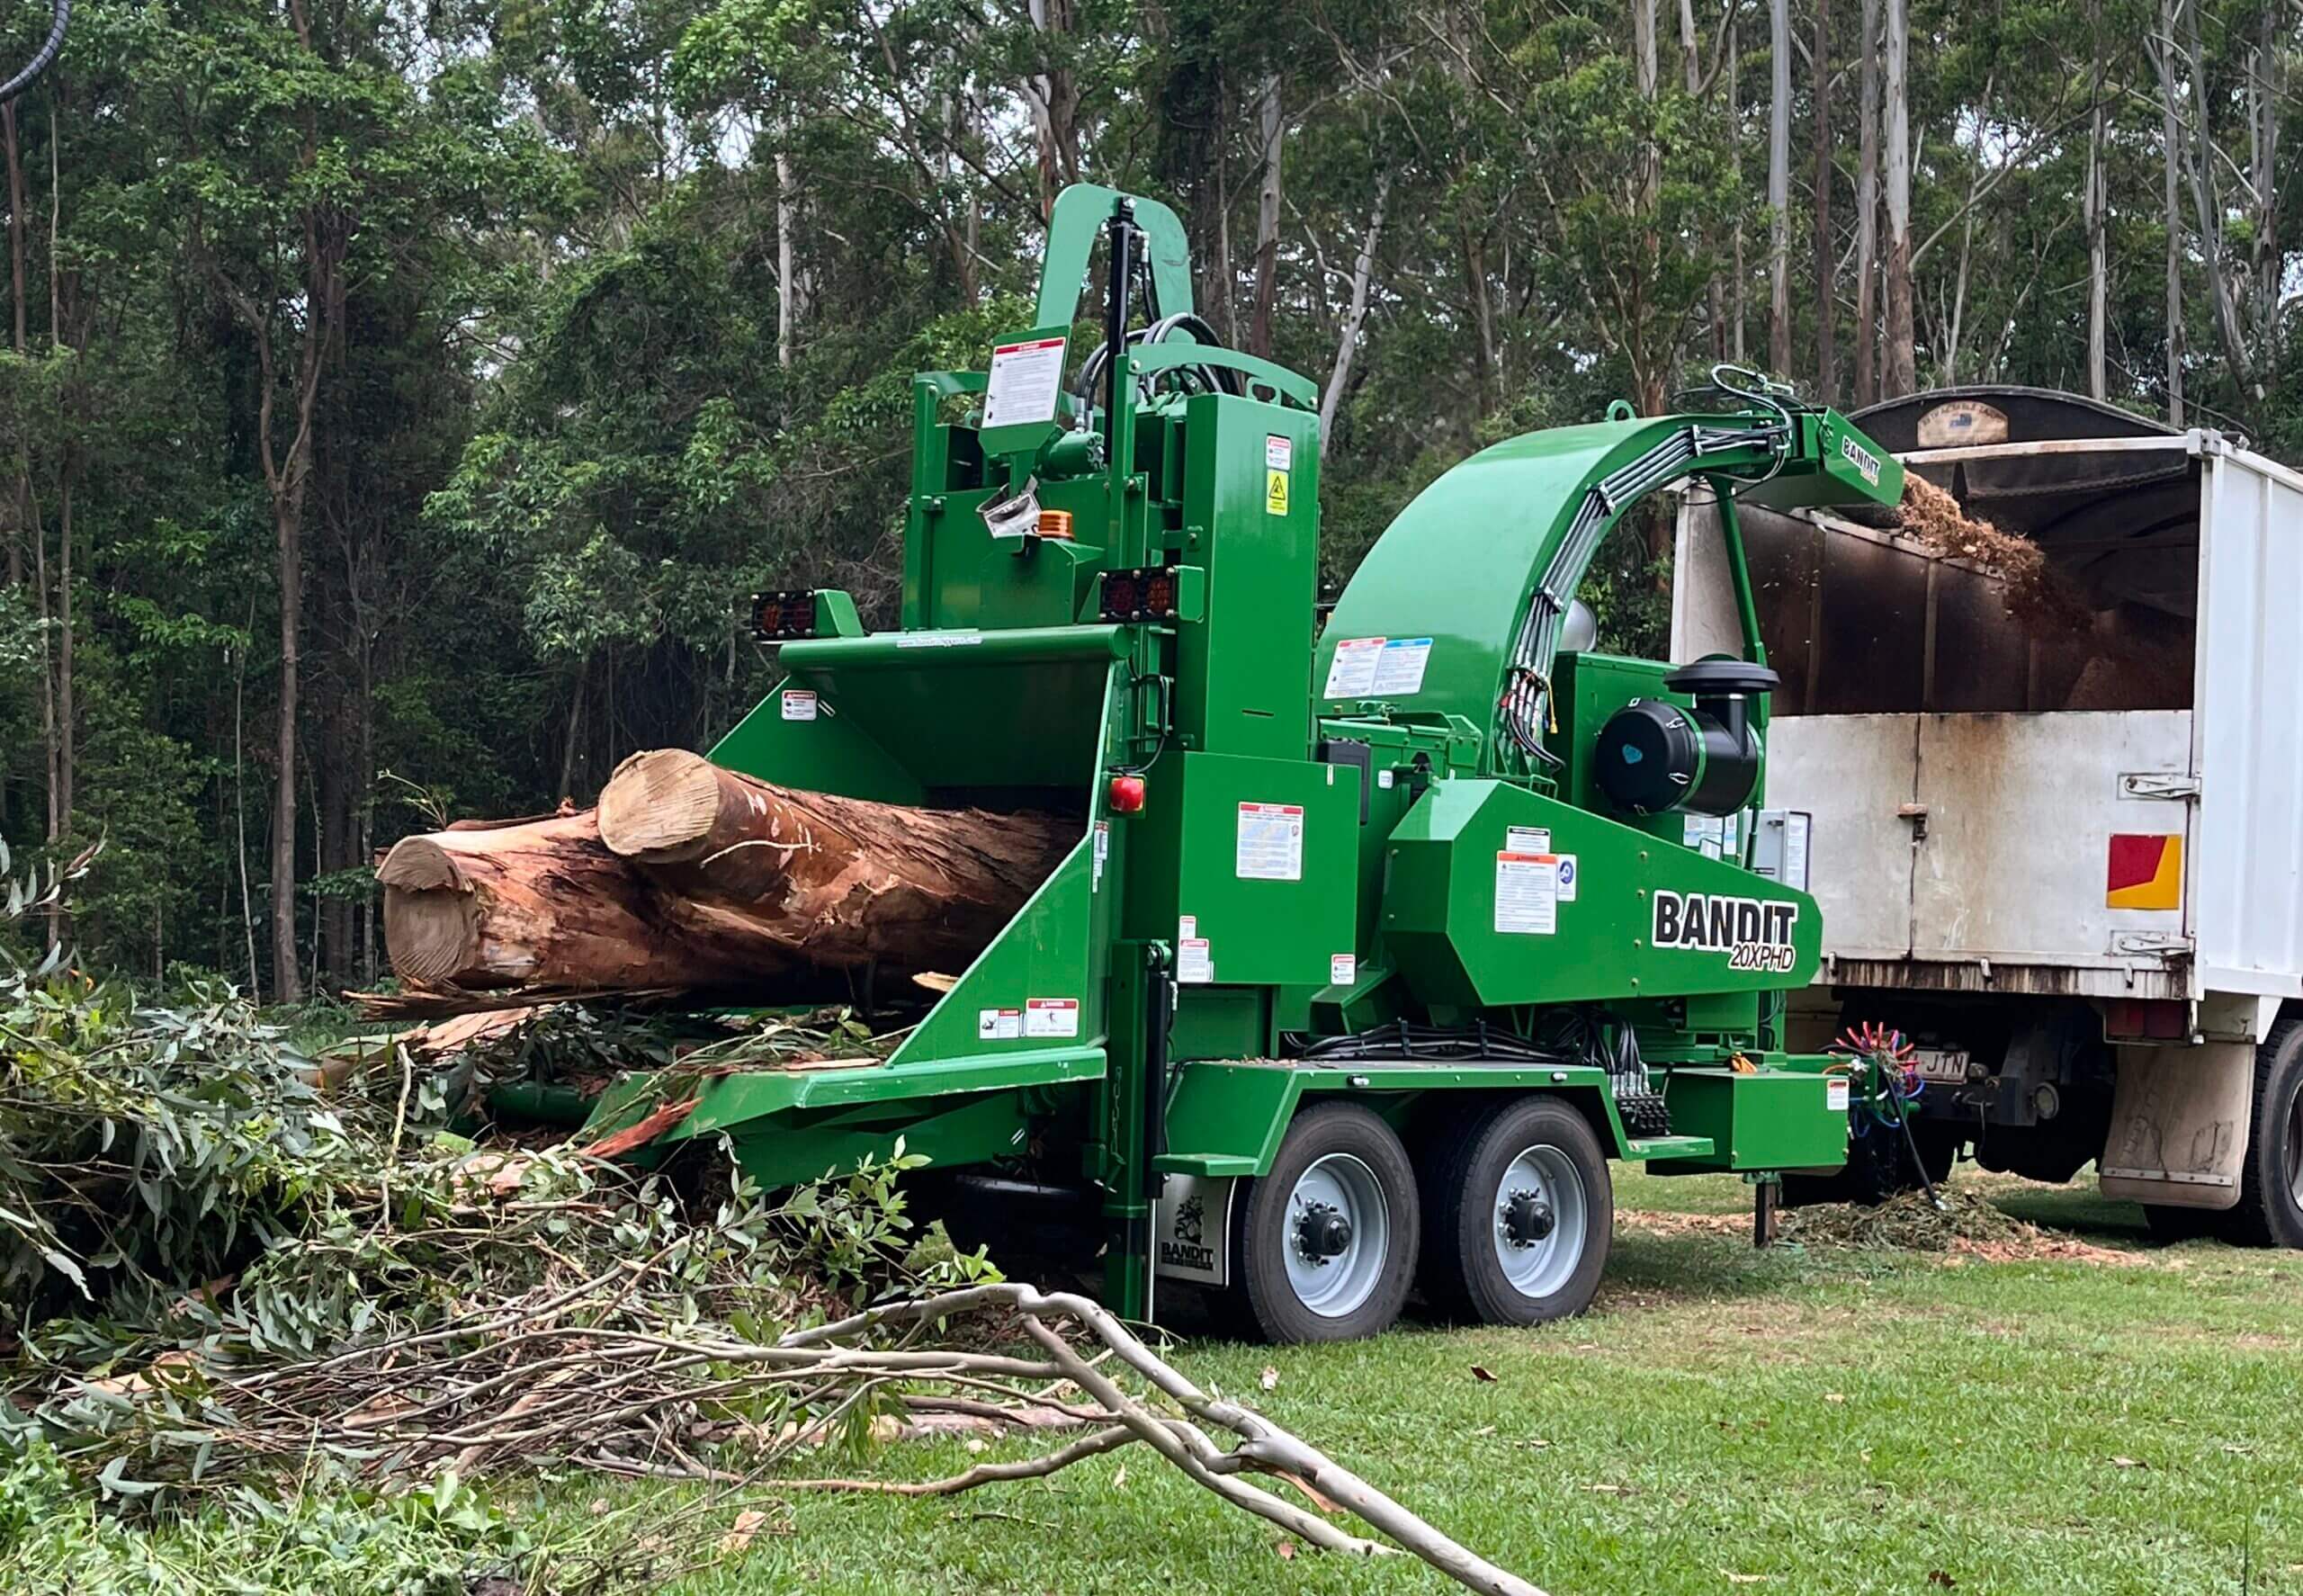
[1384,778,1822,1007]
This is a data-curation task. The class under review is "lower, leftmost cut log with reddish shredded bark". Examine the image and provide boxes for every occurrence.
[378,809,788,991]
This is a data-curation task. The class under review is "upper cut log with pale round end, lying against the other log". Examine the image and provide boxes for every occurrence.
[585,749,1080,972]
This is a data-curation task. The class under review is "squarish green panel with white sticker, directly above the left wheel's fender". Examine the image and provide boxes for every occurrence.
[1126,753,1358,986]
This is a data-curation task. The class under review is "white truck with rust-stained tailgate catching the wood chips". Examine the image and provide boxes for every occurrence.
[1672,390,2303,1211]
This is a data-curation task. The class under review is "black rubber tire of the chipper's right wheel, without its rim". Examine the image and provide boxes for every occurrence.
[1421,1097,1615,1324]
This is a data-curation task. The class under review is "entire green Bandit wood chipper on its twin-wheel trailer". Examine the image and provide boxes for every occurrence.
[594,186,1903,1340]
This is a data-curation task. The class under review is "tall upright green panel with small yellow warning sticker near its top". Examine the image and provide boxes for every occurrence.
[1177,394,1320,760]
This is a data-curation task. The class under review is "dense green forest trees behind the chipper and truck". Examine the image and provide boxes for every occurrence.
[0,0,2303,997]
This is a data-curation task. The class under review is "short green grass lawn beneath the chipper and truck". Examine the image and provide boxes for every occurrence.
[543,1172,2303,1596]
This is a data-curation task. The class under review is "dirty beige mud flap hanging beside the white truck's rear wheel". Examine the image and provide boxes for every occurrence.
[2101,1041,2254,1209]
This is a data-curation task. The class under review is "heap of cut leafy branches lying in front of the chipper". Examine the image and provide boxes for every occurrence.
[0,979,1534,1596]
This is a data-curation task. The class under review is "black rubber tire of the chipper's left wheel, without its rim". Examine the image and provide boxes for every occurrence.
[1232,1103,1423,1342]
